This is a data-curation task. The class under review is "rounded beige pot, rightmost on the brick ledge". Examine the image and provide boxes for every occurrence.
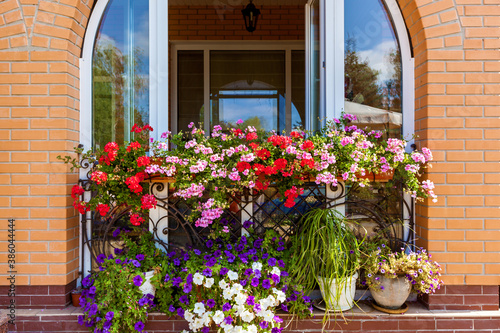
[370,275,411,309]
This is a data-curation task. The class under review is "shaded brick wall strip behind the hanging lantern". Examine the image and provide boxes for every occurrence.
[168,5,305,40]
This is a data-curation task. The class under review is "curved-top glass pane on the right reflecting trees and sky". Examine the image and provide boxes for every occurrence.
[344,0,403,137]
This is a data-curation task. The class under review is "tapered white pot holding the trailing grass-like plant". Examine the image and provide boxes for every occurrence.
[318,273,358,311]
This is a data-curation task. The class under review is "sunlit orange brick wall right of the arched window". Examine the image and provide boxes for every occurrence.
[398,0,500,286]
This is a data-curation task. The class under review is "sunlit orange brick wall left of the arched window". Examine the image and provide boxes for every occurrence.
[0,0,93,290]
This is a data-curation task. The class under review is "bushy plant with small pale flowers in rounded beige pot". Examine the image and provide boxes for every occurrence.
[364,244,443,312]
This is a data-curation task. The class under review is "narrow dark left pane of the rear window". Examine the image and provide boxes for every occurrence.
[177,51,204,132]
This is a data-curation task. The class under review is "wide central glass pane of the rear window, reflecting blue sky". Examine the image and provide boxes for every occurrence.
[210,51,286,131]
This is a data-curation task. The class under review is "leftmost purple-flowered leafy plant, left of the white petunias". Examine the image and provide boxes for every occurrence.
[78,229,161,332]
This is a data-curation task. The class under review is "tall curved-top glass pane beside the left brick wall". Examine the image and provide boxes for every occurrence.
[92,0,149,147]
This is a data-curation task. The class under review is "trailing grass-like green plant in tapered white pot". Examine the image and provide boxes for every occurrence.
[291,208,363,311]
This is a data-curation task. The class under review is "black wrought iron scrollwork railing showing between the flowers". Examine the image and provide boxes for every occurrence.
[80,179,414,273]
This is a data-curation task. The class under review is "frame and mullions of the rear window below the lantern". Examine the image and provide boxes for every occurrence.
[170,40,304,133]
